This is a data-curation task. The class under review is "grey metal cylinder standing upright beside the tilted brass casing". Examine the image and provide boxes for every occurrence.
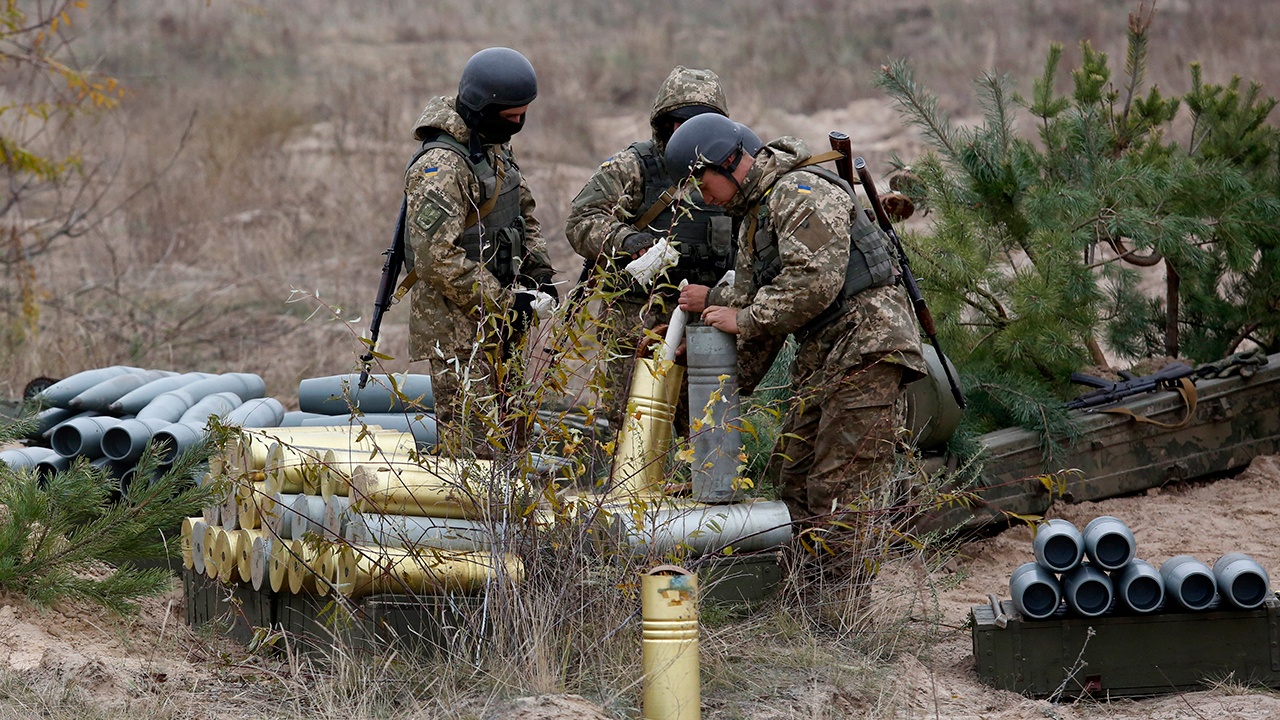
[685,323,742,502]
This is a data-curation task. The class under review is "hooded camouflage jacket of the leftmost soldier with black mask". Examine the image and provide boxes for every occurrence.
[404,97,554,360]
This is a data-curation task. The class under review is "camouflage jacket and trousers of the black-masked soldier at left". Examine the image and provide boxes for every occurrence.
[404,97,554,456]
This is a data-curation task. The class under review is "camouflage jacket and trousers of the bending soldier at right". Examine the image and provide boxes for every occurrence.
[707,137,927,520]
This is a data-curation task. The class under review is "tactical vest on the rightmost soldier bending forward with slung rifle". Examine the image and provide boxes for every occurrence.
[746,165,899,342]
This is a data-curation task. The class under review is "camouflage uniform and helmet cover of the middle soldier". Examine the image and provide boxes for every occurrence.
[564,65,735,428]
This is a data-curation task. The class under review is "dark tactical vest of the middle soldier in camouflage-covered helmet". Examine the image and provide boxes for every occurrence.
[630,140,737,286]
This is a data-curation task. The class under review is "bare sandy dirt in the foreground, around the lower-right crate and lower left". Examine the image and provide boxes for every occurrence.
[0,456,1280,720]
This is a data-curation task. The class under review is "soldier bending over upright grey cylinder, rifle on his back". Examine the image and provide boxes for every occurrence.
[667,115,925,535]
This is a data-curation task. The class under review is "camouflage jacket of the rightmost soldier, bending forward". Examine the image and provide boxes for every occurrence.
[707,137,925,388]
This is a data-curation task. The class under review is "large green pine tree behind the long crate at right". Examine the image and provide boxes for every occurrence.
[877,2,1280,434]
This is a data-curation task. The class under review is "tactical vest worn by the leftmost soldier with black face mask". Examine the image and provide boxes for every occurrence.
[406,132,525,286]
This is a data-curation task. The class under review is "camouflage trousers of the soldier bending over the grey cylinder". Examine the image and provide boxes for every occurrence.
[771,361,905,525]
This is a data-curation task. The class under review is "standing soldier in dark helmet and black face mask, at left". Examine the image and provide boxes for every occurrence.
[404,47,557,456]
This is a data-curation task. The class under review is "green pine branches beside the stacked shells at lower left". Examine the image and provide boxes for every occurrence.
[0,412,212,614]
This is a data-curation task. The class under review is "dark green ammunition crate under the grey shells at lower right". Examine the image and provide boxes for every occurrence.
[972,596,1280,698]
